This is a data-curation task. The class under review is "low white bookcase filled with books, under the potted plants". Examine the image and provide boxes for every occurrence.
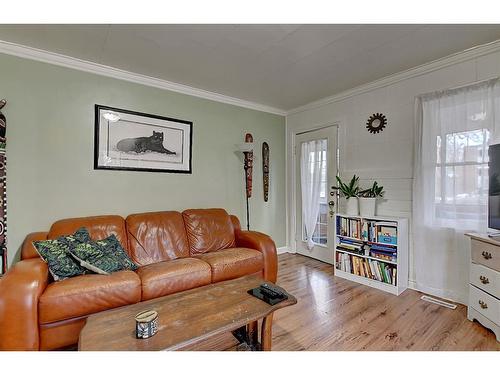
[334,214,408,295]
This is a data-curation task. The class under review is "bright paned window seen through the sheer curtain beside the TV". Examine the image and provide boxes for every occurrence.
[435,129,489,220]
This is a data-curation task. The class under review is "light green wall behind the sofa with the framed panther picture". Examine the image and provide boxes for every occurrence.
[0,54,285,263]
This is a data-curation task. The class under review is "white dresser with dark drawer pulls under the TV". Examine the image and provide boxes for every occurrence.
[467,233,500,341]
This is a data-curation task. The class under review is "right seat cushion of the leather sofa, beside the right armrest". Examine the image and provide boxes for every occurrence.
[197,247,264,283]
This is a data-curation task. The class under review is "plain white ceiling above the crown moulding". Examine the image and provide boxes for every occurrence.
[0,24,500,110]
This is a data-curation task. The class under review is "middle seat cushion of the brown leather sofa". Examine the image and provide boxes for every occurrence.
[137,258,212,301]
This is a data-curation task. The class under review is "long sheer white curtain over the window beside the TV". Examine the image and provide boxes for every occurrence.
[412,79,500,302]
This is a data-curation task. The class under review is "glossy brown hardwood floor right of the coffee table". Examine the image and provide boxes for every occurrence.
[272,254,500,351]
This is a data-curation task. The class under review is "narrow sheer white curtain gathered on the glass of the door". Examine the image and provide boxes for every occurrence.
[300,139,327,249]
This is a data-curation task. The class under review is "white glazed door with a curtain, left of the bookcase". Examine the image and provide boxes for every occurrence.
[295,126,338,264]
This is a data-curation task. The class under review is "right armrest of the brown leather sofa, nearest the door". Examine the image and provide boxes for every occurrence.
[234,230,278,283]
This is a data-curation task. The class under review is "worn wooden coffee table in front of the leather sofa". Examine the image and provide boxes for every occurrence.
[78,276,297,351]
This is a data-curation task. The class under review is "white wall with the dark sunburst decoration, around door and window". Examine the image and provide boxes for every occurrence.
[287,47,500,301]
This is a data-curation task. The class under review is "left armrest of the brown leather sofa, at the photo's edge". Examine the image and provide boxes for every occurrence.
[0,258,49,350]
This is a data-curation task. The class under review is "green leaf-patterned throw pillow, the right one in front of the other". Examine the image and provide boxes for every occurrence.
[70,234,138,275]
